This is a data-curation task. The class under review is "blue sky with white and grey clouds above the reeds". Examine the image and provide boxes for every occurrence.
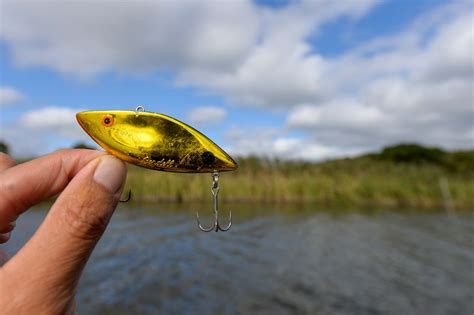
[0,0,474,161]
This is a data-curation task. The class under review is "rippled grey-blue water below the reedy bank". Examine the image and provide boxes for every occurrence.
[1,204,474,315]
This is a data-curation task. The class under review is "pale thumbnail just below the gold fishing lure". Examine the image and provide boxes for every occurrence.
[94,155,127,194]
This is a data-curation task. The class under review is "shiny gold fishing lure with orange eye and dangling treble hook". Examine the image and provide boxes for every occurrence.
[76,106,237,232]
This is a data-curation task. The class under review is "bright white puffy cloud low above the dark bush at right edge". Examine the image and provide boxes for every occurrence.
[287,80,474,150]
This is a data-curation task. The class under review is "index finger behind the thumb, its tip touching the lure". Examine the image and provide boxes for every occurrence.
[0,149,104,227]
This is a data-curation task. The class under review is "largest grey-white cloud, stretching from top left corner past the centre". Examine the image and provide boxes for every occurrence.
[0,0,378,94]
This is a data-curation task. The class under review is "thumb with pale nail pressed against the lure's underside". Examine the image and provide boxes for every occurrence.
[4,155,127,310]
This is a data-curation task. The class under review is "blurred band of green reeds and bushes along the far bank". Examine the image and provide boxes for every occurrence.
[123,145,474,210]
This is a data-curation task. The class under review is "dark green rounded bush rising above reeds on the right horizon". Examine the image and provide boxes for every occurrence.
[378,144,447,165]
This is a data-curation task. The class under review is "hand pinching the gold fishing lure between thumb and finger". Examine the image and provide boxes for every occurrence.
[0,150,127,315]
